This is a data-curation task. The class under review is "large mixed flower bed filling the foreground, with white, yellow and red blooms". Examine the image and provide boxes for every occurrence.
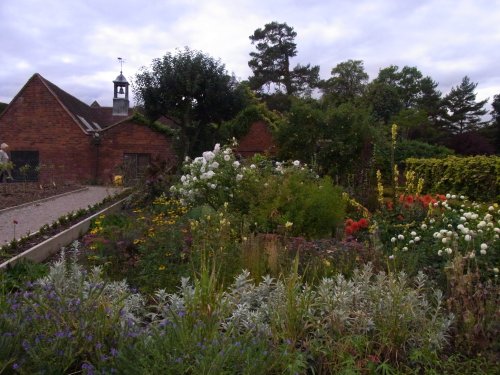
[0,143,500,374]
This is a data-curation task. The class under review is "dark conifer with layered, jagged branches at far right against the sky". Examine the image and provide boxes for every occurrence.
[442,76,488,134]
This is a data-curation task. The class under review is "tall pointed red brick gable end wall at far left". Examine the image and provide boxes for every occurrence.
[0,76,95,183]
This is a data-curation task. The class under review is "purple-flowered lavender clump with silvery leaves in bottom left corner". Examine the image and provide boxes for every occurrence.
[0,247,144,373]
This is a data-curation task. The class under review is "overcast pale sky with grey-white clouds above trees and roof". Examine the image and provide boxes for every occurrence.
[0,0,500,113]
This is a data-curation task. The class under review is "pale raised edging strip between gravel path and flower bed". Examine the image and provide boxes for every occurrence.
[0,197,128,271]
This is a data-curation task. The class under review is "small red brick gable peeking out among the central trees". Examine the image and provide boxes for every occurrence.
[236,121,276,157]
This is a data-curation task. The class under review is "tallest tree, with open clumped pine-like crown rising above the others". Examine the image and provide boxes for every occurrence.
[248,22,319,95]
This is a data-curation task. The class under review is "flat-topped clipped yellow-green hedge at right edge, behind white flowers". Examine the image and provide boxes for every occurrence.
[406,156,500,201]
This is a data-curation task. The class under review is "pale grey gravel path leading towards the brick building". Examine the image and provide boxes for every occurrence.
[0,186,121,246]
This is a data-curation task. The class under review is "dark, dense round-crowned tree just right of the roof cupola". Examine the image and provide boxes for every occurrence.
[134,47,244,157]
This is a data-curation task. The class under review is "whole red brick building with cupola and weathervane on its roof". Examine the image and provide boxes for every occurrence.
[0,72,175,183]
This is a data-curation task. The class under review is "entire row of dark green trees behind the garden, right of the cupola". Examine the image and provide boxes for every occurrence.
[134,22,500,191]
